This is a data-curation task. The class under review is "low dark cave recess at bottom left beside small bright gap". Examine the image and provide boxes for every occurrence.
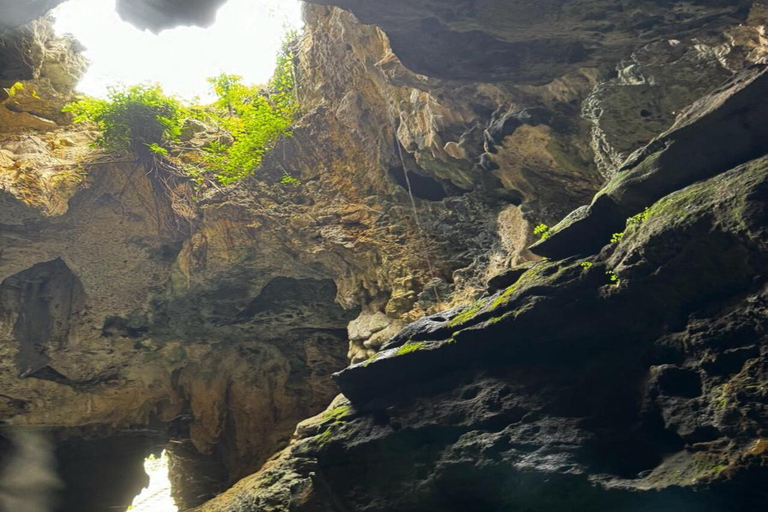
[0,427,171,512]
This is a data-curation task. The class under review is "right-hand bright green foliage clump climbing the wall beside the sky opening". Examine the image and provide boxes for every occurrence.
[205,33,299,184]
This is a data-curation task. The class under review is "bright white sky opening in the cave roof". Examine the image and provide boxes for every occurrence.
[53,0,302,103]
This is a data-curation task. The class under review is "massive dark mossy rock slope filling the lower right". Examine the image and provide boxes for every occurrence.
[196,150,768,512]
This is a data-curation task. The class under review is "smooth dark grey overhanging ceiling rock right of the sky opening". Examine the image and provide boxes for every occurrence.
[294,0,751,84]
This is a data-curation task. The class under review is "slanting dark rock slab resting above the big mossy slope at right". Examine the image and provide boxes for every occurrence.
[531,65,768,258]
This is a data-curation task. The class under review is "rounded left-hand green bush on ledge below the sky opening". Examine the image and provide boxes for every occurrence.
[63,84,186,157]
